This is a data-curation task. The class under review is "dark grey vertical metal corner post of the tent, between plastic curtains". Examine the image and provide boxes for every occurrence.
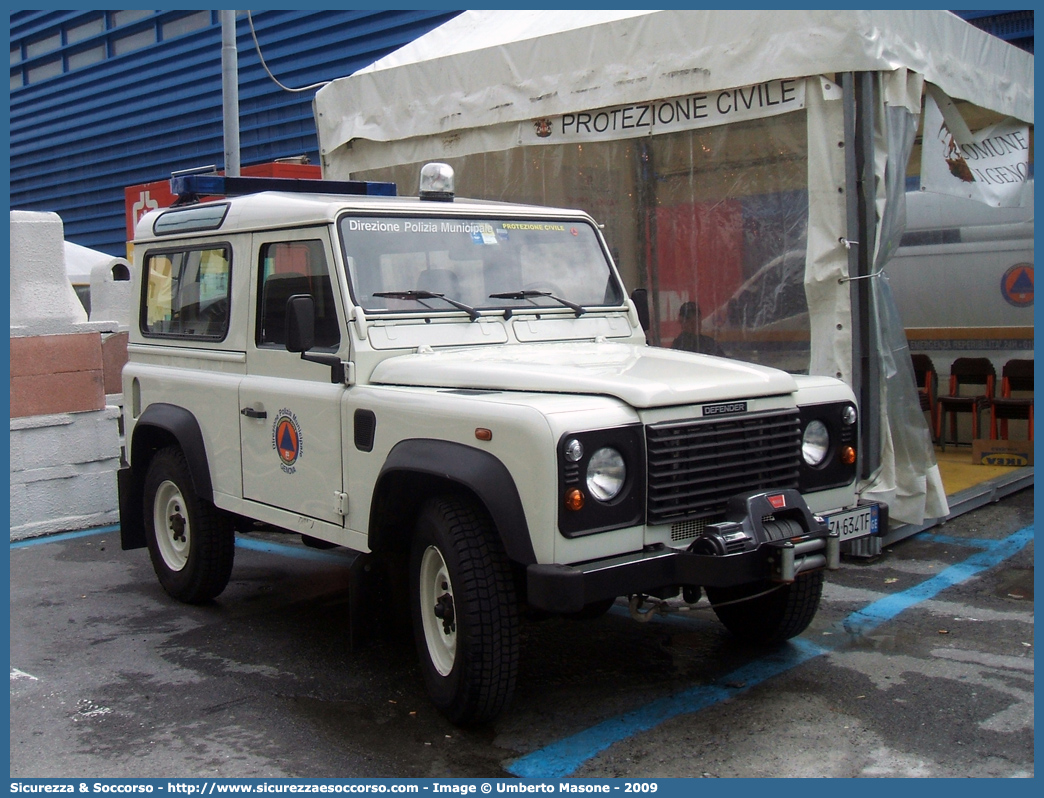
[841,72,883,478]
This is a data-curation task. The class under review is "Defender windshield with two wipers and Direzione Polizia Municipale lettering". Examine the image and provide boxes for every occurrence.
[340,216,624,315]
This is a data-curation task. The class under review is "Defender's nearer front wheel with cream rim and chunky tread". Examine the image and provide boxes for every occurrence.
[409,496,519,726]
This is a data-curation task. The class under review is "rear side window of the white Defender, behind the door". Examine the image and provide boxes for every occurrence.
[141,247,232,341]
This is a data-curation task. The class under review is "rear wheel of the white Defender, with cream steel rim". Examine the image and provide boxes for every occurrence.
[144,446,235,604]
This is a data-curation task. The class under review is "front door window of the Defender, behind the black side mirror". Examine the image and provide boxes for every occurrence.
[257,240,340,349]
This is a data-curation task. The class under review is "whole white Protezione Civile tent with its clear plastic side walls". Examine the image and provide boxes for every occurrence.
[314,10,1034,523]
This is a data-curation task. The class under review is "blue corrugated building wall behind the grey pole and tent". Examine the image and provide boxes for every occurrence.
[10,10,455,255]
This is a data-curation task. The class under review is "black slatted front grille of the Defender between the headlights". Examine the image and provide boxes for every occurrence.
[645,410,801,523]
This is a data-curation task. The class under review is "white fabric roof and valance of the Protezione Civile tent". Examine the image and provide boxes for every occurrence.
[315,10,1034,168]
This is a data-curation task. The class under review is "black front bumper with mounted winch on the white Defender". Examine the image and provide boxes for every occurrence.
[526,489,840,612]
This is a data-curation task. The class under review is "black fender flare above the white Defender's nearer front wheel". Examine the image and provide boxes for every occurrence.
[369,438,537,565]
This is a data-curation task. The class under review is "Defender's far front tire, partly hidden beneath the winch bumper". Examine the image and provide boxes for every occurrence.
[707,570,823,644]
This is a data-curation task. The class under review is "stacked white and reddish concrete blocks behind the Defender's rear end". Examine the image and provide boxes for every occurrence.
[10,211,126,540]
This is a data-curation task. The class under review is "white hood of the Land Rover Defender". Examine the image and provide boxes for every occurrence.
[370,343,797,407]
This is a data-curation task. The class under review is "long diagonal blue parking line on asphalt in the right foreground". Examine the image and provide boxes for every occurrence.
[505,526,1034,778]
